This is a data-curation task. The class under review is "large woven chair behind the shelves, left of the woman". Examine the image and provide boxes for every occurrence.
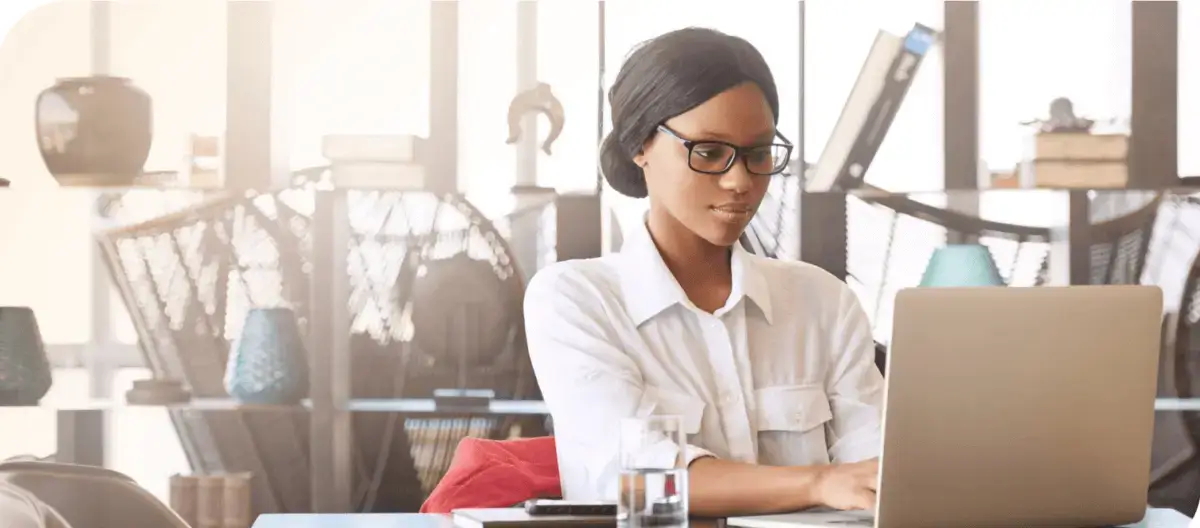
[96,168,552,514]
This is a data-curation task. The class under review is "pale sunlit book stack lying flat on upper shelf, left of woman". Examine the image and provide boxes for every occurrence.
[322,134,426,191]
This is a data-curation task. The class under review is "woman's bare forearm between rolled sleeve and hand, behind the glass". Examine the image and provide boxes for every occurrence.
[688,457,827,517]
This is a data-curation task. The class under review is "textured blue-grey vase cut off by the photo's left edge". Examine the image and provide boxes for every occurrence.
[0,306,52,406]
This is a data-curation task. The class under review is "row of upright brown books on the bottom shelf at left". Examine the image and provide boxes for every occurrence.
[170,473,252,528]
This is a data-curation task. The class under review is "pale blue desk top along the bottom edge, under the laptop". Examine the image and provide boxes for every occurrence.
[252,510,1190,528]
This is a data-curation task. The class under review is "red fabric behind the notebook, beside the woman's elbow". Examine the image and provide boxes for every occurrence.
[421,437,563,514]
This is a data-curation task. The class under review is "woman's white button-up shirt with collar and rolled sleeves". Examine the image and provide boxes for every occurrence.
[524,218,883,500]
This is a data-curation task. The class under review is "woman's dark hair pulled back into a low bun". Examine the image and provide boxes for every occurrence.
[600,28,779,198]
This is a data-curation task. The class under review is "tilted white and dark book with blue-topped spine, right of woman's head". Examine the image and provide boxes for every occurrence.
[805,24,936,192]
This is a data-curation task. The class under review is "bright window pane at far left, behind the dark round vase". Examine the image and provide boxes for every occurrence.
[0,2,91,343]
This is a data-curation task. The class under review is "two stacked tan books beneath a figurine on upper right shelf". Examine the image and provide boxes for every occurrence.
[1019,132,1129,188]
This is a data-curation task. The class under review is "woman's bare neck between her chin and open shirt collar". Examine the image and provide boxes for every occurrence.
[647,210,733,312]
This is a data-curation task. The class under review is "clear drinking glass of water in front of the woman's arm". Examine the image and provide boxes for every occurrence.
[617,415,688,528]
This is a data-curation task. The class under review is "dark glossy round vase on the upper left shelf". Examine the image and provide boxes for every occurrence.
[36,76,152,186]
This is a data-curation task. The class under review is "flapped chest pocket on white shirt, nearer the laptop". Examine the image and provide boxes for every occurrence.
[755,385,833,466]
